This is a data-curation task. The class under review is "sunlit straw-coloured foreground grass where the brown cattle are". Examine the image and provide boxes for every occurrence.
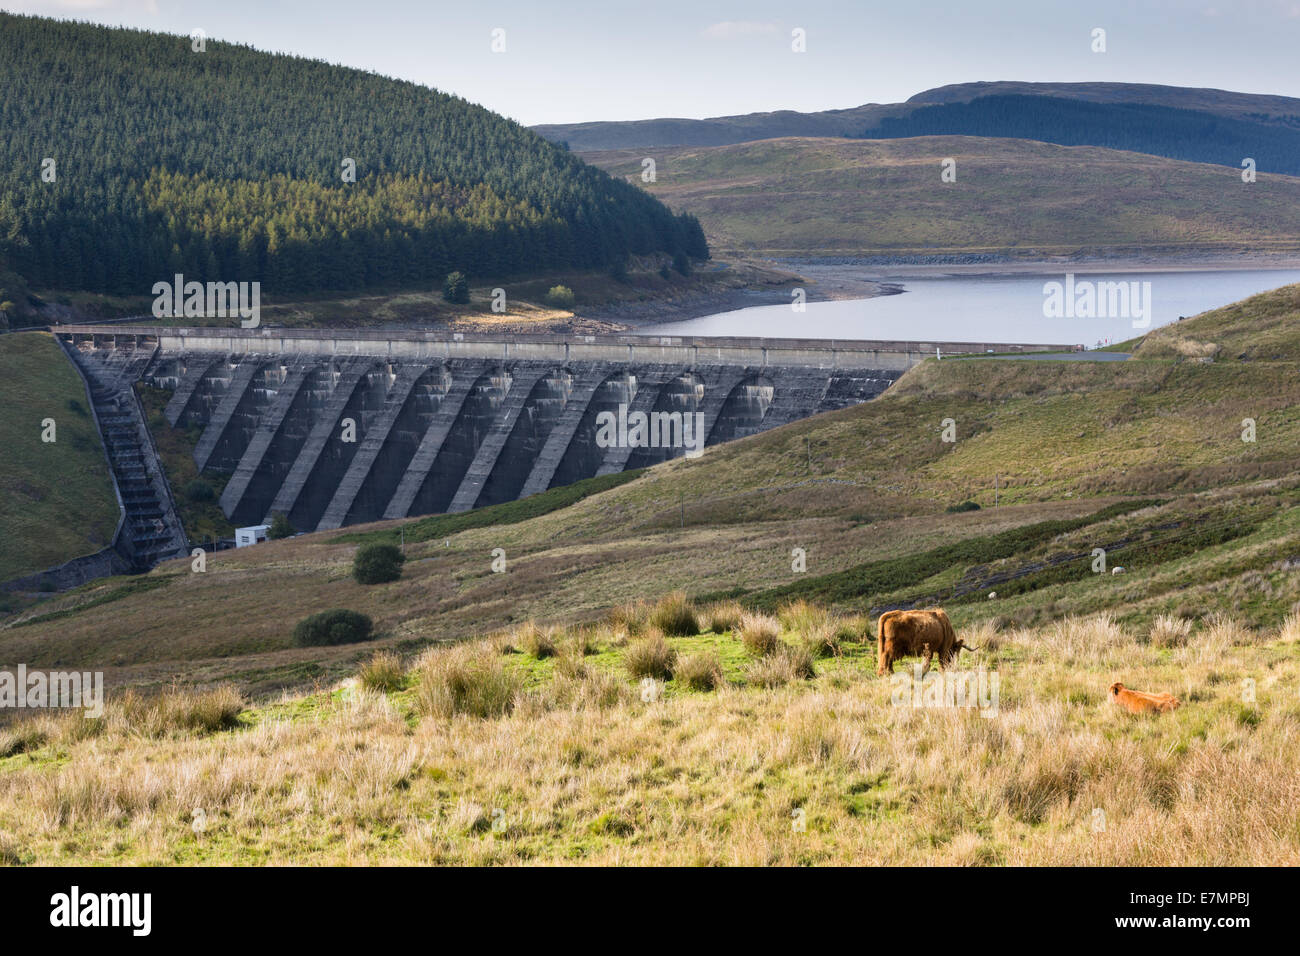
[0,606,1300,866]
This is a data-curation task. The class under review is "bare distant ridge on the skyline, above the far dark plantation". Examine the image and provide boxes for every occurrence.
[533,81,1300,152]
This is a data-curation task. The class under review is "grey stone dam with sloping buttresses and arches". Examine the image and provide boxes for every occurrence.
[52,325,1069,557]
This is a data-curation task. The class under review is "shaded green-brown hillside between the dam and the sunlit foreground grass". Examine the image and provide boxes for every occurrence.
[0,286,1300,692]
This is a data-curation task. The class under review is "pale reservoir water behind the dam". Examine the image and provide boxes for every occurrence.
[636,269,1300,347]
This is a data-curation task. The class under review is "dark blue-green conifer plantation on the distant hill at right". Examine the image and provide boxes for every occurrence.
[862,94,1300,176]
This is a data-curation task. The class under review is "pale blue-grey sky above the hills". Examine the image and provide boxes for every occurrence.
[0,0,1300,125]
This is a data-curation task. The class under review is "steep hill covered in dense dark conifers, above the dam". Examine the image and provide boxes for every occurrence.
[0,13,709,295]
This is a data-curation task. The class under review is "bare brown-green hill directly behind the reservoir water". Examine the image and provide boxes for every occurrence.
[586,137,1300,258]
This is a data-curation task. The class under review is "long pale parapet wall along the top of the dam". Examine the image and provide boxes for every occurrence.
[55,325,1074,369]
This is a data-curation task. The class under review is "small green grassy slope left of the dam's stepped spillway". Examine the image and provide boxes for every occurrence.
[0,333,118,581]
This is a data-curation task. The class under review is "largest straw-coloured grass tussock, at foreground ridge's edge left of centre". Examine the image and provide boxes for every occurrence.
[416,646,523,718]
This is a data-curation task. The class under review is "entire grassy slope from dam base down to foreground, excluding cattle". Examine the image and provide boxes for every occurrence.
[0,286,1300,866]
